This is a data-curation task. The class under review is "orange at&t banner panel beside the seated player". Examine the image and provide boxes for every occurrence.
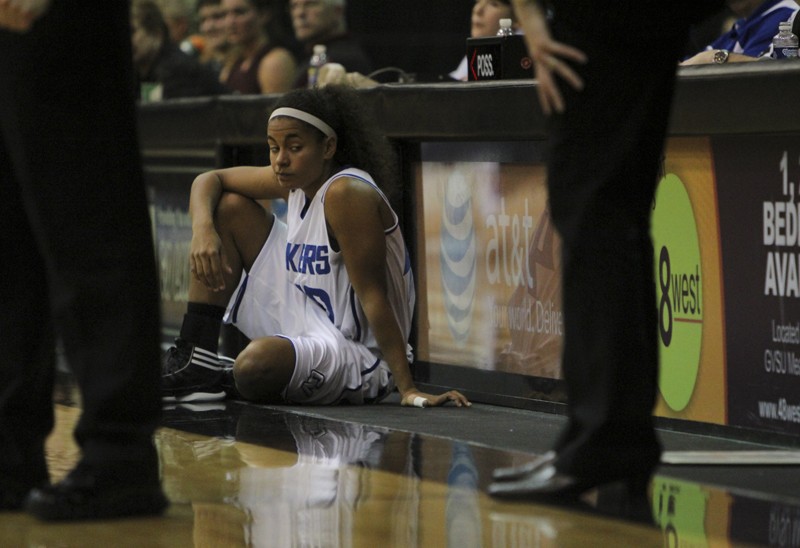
[415,144,563,378]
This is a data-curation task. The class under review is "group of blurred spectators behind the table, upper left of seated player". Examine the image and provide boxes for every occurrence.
[131,0,372,102]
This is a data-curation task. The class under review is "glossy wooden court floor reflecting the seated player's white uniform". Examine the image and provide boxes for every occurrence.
[0,405,764,548]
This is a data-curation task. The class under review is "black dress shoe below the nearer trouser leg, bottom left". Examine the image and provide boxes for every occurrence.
[24,463,169,521]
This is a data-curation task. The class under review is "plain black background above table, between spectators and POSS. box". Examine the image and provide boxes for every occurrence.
[347,0,474,81]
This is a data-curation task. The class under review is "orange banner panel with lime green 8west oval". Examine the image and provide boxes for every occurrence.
[651,138,725,424]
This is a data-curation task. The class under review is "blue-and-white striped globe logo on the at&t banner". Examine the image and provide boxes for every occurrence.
[440,171,476,342]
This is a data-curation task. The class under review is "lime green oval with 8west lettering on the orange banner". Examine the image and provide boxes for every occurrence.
[652,173,703,411]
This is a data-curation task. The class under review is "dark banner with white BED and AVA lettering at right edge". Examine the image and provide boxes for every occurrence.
[714,136,800,434]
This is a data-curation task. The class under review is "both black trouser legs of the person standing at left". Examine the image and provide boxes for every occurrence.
[0,0,161,517]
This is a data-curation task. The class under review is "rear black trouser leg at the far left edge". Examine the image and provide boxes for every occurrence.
[0,137,55,488]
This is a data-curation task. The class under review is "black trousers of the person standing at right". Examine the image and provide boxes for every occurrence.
[548,11,685,485]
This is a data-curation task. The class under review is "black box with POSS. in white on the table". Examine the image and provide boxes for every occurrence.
[467,34,533,82]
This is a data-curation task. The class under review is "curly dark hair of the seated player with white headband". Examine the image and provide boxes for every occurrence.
[273,86,398,199]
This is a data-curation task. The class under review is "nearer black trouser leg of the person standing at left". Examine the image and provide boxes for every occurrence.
[3,0,161,461]
